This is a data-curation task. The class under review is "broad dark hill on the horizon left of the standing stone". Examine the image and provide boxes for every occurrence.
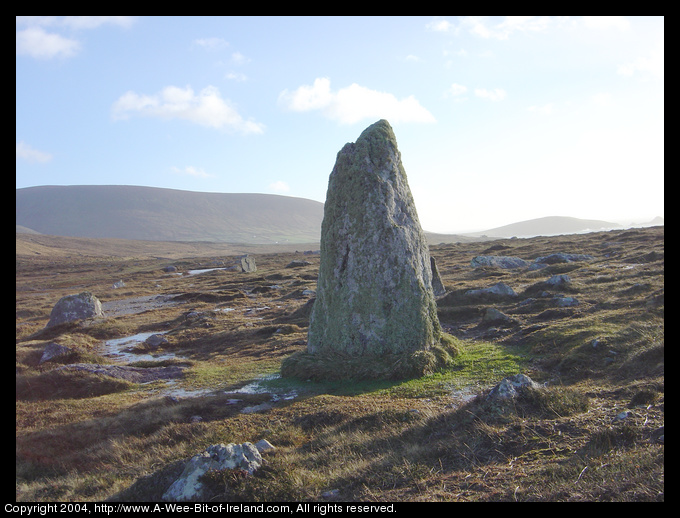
[16,185,323,244]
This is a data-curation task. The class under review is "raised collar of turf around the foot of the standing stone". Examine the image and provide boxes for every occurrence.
[281,335,458,381]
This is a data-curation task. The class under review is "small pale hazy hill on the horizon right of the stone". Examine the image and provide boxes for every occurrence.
[474,216,622,237]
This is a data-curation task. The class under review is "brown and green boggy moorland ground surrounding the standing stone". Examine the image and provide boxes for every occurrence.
[16,227,664,502]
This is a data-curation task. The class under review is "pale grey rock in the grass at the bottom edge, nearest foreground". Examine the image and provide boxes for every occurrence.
[162,442,262,502]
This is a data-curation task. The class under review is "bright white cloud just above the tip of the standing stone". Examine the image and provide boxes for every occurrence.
[279,78,435,124]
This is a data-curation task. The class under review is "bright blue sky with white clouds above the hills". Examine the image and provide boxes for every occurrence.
[16,16,664,232]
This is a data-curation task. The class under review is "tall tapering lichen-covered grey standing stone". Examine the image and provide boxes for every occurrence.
[282,120,452,378]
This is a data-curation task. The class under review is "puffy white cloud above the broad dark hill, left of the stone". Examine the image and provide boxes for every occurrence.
[111,86,264,134]
